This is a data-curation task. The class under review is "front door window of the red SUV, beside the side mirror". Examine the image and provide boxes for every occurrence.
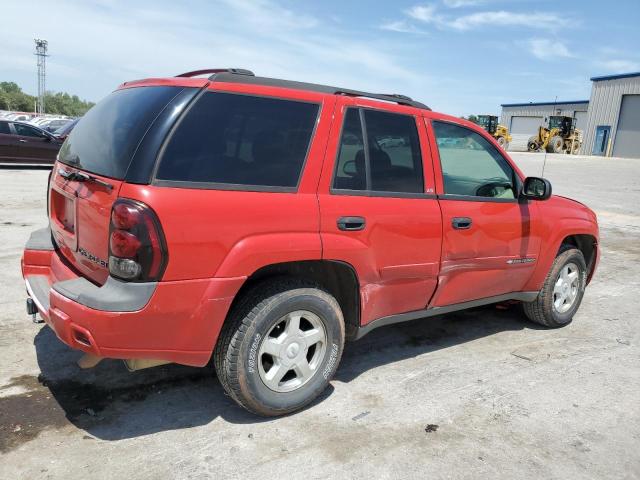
[433,122,516,198]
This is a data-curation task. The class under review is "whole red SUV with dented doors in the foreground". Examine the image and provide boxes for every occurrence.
[22,69,599,415]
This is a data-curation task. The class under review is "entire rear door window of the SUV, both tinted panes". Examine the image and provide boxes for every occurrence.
[333,108,424,193]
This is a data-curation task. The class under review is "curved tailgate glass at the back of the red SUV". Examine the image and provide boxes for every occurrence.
[58,86,182,179]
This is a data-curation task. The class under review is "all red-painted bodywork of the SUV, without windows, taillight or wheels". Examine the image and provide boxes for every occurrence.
[22,78,599,365]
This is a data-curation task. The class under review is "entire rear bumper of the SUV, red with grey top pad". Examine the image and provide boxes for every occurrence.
[22,228,245,366]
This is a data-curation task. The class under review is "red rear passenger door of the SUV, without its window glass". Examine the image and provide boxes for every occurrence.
[318,98,442,325]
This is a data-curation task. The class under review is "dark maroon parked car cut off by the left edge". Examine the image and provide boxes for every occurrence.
[0,120,62,165]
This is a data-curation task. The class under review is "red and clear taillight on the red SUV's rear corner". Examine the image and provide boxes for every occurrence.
[109,199,167,282]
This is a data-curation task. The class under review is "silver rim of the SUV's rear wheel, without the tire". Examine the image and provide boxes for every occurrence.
[258,310,327,392]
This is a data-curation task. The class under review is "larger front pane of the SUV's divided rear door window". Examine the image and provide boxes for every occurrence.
[364,110,424,193]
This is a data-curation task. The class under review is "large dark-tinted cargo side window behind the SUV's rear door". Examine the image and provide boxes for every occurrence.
[157,92,319,187]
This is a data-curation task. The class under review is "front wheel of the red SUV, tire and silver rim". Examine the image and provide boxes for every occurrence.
[522,245,587,328]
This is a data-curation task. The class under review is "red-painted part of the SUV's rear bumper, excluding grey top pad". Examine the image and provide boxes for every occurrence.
[22,246,245,366]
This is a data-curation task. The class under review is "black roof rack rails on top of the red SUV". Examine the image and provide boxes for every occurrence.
[185,68,431,110]
